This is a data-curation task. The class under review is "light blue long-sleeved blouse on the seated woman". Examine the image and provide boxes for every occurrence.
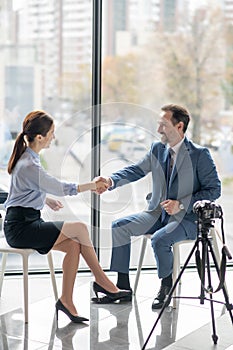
[5,147,78,210]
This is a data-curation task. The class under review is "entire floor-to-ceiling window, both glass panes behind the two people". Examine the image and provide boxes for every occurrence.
[0,0,233,268]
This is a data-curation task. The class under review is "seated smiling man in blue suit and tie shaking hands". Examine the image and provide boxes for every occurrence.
[94,104,221,309]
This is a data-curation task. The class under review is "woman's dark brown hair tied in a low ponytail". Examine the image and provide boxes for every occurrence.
[8,111,53,174]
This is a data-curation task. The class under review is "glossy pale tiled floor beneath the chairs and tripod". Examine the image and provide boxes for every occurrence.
[0,268,233,350]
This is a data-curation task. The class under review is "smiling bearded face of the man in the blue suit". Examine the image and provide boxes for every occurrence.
[158,111,184,147]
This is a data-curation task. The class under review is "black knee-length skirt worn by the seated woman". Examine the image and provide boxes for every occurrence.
[4,207,64,254]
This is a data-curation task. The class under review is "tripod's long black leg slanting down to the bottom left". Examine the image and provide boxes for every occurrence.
[141,238,199,350]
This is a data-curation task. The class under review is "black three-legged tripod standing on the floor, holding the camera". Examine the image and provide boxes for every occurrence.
[142,217,233,350]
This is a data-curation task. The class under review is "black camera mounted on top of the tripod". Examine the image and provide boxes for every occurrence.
[193,200,222,221]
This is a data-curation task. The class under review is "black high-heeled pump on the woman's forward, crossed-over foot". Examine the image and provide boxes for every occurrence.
[92,282,132,303]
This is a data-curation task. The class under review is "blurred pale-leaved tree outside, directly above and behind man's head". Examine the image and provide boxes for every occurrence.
[159,11,223,143]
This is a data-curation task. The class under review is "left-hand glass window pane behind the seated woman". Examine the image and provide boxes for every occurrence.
[0,0,92,269]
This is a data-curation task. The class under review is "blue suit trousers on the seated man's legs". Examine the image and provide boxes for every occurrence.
[110,210,197,278]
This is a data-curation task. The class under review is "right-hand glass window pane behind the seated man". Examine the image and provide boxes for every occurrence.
[101,0,233,267]
